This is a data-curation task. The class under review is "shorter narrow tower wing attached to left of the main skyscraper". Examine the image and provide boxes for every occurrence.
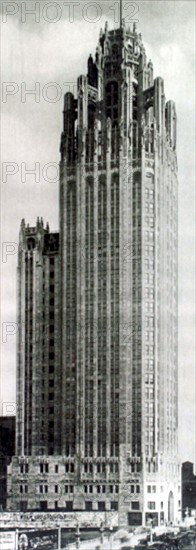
[16,218,61,456]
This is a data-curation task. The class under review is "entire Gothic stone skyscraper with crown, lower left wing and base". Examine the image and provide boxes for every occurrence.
[7,16,181,525]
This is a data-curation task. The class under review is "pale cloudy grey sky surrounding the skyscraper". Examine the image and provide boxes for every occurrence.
[0,0,196,468]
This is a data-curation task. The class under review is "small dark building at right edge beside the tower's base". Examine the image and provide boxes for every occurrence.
[182,462,196,517]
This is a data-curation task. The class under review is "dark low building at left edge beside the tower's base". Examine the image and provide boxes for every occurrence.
[0,416,16,510]
